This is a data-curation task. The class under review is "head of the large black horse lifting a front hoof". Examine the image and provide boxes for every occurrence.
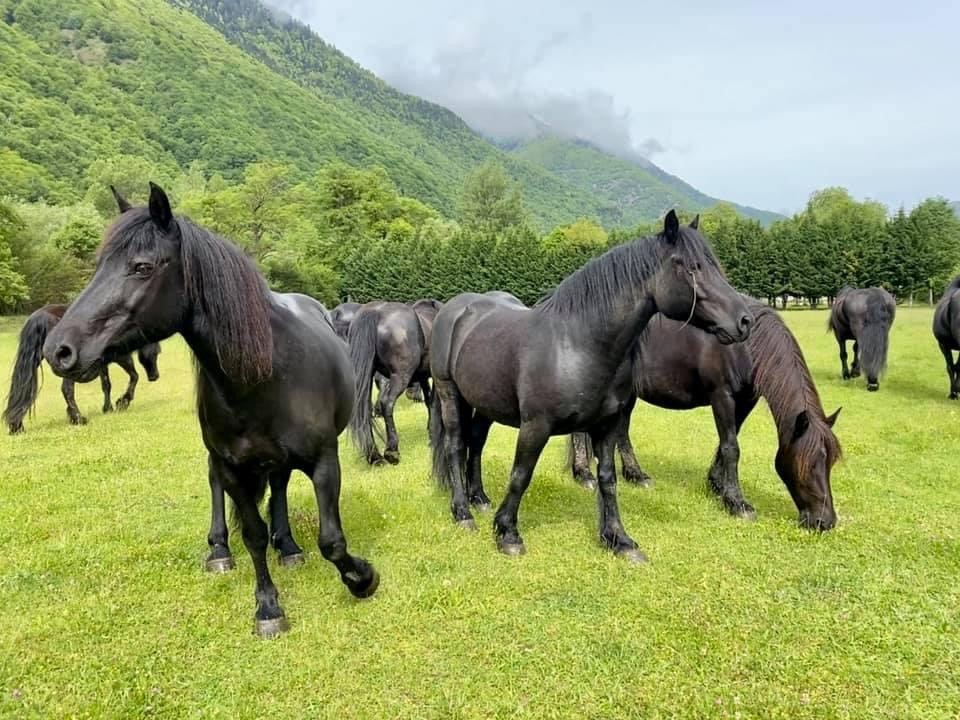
[43,183,188,382]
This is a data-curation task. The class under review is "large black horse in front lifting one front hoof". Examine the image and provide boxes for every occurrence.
[44,183,379,636]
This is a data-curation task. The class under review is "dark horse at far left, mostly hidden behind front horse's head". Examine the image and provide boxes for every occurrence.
[3,305,160,435]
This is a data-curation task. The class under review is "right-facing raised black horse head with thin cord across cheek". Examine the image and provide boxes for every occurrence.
[654,210,753,344]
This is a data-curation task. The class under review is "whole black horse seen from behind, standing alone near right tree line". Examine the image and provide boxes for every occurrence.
[828,286,897,392]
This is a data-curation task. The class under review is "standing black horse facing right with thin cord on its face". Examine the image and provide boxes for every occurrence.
[430,210,752,561]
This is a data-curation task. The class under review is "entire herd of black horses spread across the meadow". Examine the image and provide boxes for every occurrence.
[4,183,960,636]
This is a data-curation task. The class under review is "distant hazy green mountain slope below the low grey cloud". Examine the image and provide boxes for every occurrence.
[511,134,781,225]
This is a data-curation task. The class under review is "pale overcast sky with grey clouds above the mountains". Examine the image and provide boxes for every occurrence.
[270,0,960,212]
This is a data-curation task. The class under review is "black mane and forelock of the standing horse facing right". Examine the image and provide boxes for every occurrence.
[534,226,720,323]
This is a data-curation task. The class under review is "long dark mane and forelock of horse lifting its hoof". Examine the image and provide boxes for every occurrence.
[100,208,273,384]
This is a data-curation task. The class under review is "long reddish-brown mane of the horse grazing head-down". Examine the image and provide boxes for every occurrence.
[747,298,842,472]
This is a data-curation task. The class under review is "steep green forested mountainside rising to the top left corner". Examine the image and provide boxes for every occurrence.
[0,0,772,229]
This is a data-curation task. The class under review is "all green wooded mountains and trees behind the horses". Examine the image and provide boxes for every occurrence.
[0,0,960,312]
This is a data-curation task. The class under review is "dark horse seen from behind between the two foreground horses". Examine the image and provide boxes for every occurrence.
[347,301,430,465]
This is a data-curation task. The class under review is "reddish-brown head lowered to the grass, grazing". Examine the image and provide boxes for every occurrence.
[775,409,840,531]
